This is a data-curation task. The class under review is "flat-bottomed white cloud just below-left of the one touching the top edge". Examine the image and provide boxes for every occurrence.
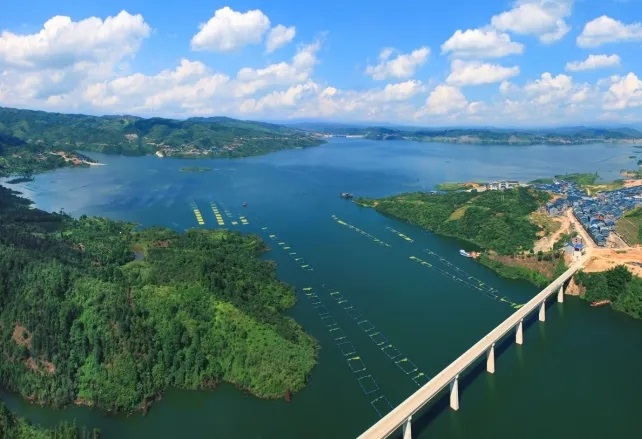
[441,28,524,58]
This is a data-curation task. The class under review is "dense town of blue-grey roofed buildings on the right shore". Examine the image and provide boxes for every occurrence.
[533,181,642,246]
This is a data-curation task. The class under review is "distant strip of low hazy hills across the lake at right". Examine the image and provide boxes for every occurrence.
[296,123,642,145]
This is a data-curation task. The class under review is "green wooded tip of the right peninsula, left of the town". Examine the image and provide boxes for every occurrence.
[356,187,548,255]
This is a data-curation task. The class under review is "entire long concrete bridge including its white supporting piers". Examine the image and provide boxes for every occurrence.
[358,256,587,439]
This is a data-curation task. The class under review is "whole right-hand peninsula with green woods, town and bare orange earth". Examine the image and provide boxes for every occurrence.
[355,174,642,318]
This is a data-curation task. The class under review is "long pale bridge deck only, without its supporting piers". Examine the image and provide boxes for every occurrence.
[359,258,585,439]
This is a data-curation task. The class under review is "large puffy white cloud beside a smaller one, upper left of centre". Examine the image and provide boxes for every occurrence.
[192,6,270,52]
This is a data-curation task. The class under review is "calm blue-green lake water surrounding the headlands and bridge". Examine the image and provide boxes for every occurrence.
[0,139,642,438]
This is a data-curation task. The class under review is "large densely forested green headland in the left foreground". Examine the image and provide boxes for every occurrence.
[0,186,317,410]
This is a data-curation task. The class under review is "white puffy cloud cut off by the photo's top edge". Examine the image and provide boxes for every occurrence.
[491,0,573,43]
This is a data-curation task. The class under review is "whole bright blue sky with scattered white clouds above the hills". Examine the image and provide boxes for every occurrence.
[0,0,642,126]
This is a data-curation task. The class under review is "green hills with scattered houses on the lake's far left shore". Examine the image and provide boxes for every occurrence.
[0,107,322,174]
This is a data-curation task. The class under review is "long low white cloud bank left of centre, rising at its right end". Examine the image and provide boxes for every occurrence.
[83,42,320,114]
